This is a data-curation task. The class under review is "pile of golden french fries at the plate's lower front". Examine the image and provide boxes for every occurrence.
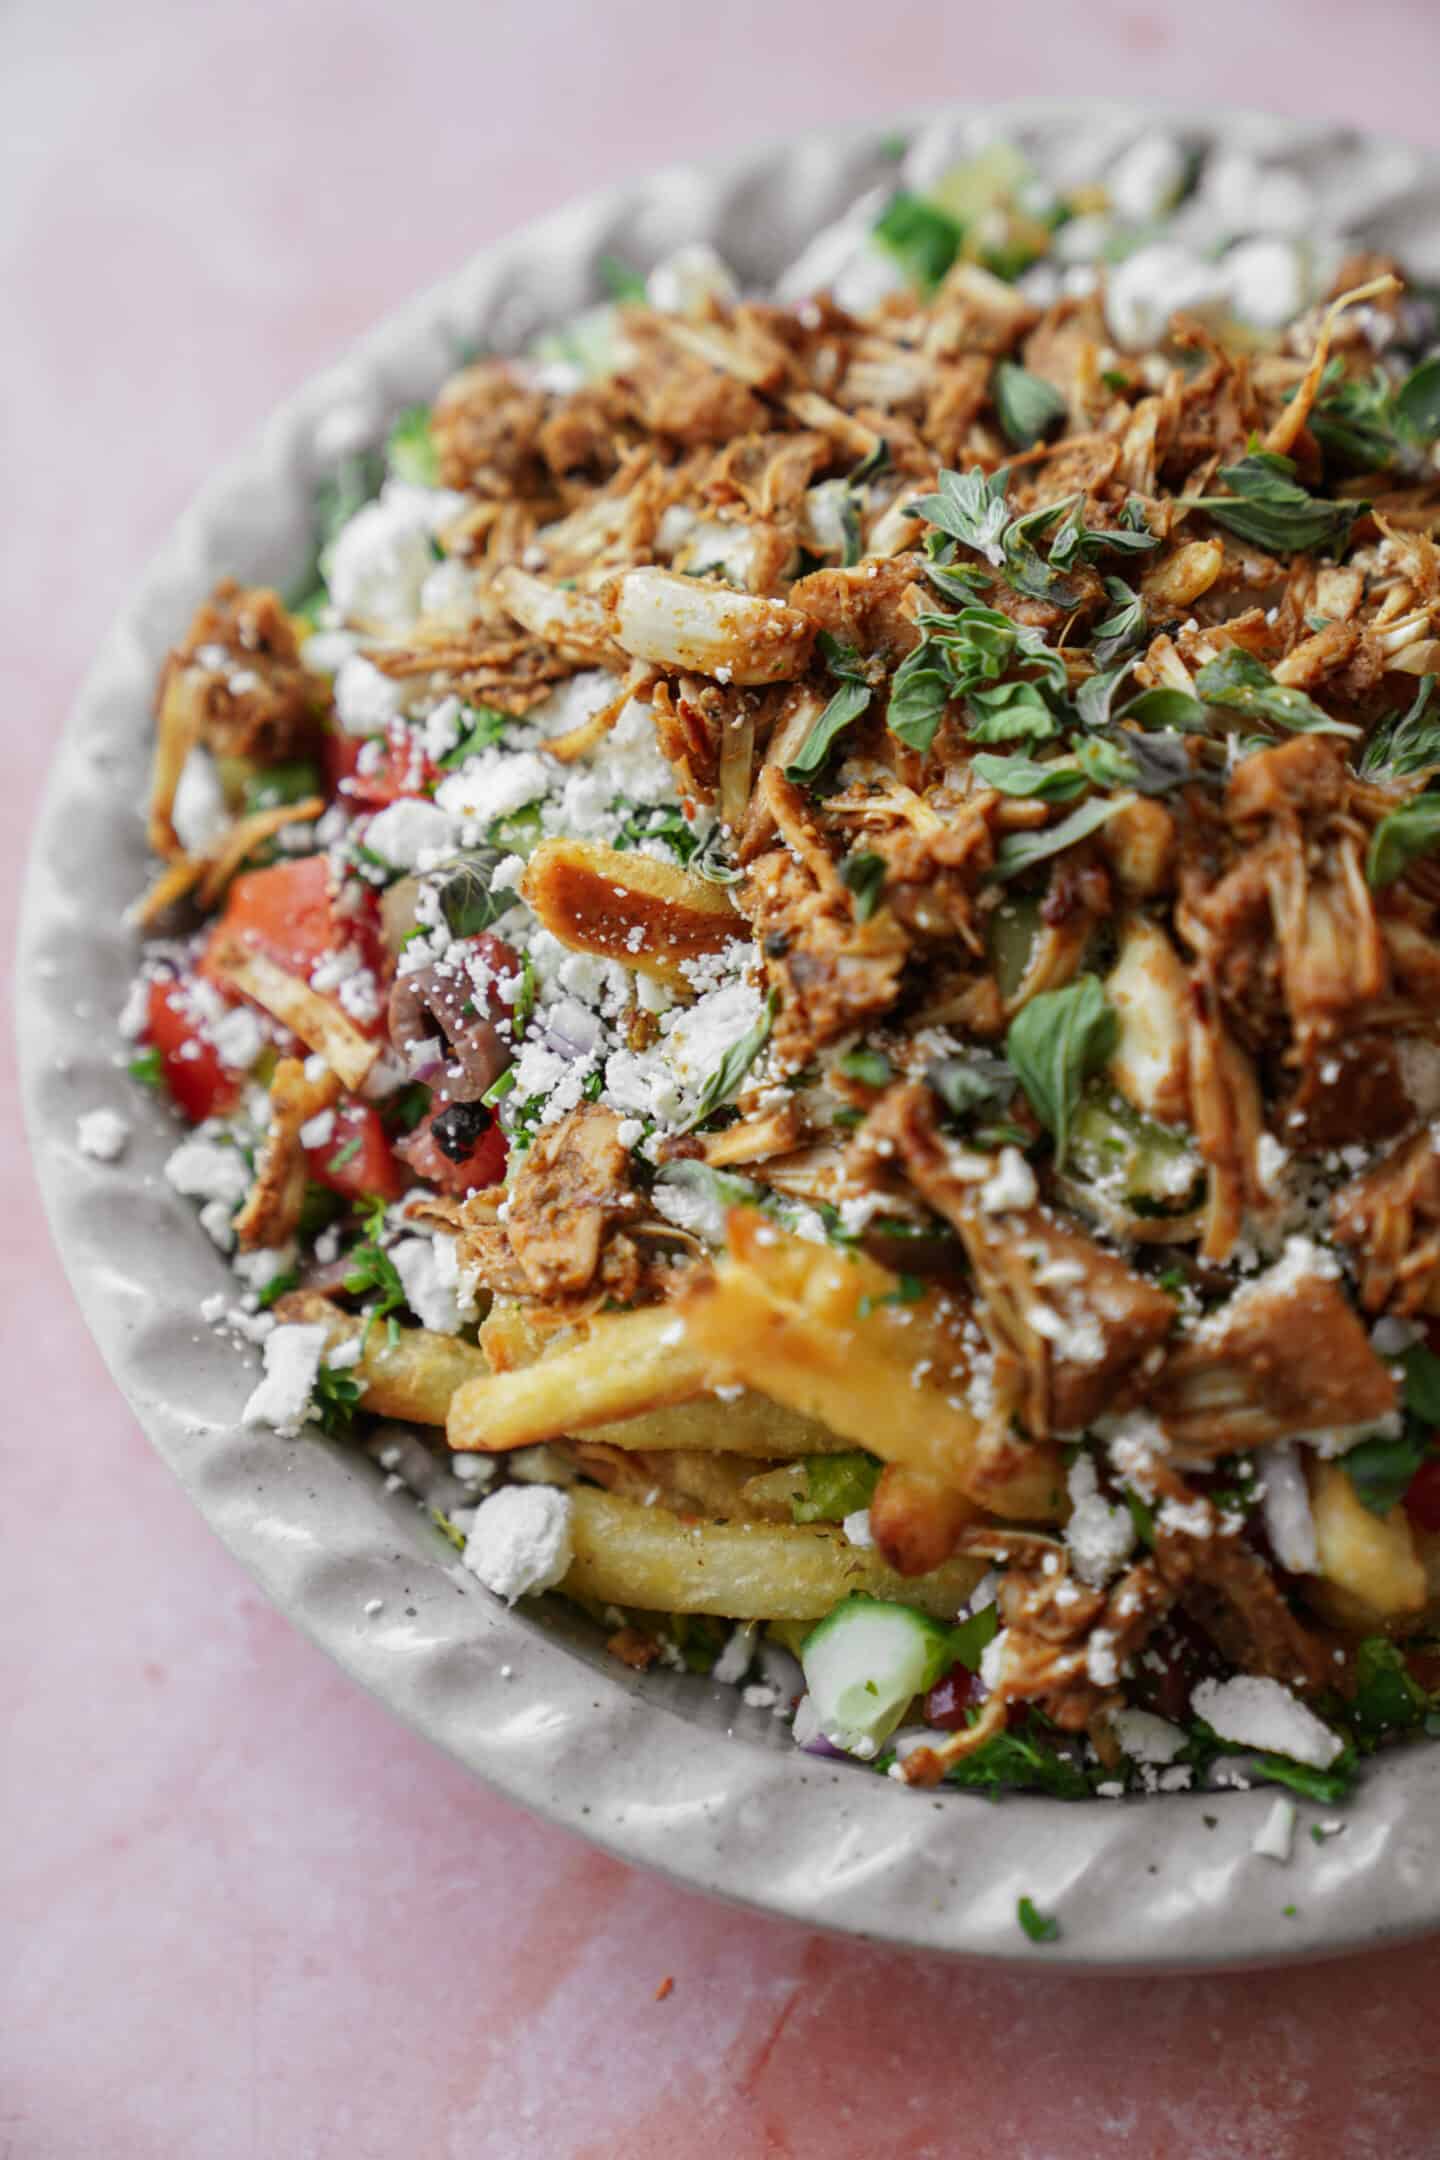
[279,1207,1079,1620]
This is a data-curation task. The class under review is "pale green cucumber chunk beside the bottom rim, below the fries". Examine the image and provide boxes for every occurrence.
[801,1592,954,1756]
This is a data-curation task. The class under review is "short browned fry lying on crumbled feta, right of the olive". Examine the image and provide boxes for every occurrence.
[520,840,745,991]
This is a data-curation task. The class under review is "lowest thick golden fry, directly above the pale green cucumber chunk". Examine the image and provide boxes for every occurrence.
[561,1486,987,1620]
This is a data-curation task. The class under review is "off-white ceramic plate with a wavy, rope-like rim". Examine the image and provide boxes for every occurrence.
[17,104,1440,1968]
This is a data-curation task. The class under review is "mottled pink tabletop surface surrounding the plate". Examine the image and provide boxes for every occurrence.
[0,0,1440,2160]
